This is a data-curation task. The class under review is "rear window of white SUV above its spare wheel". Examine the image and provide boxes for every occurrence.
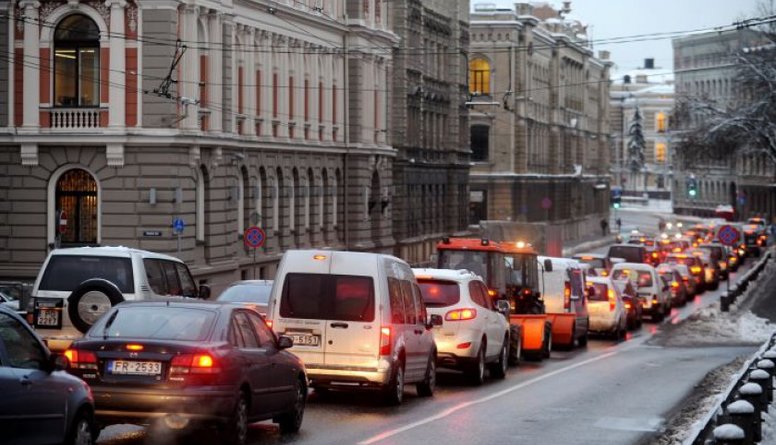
[39,255,135,294]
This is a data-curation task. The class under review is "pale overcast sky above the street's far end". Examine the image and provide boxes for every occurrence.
[482,0,776,71]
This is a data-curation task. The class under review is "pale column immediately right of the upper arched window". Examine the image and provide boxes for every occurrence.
[105,0,127,128]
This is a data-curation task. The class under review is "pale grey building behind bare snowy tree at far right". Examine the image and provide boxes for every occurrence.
[672,29,764,216]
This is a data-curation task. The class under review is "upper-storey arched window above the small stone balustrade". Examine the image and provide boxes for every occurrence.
[54,14,100,107]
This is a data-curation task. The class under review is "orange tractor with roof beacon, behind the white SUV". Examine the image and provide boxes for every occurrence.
[437,238,553,365]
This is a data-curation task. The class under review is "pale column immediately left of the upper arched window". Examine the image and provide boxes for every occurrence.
[19,0,40,128]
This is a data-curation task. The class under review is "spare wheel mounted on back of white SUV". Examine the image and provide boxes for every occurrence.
[67,280,124,333]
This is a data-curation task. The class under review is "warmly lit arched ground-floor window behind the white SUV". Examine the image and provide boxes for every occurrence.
[55,168,97,245]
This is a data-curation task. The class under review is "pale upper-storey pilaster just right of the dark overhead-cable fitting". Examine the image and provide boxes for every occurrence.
[180,5,200,130]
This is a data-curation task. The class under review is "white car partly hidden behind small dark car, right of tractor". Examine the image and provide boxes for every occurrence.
[612,263,671,322]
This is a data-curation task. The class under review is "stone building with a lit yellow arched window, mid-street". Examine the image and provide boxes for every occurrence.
[468,3,611,240]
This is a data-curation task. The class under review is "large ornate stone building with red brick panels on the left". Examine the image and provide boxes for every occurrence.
[0,0,398,292]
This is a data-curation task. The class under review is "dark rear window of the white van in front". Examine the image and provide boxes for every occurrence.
[280,273,375,322]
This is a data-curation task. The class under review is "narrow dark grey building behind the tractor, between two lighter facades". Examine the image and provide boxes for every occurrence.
[388,0,469,264]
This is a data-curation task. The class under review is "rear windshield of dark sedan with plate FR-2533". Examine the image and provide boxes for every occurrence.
[93,306,216,341]
